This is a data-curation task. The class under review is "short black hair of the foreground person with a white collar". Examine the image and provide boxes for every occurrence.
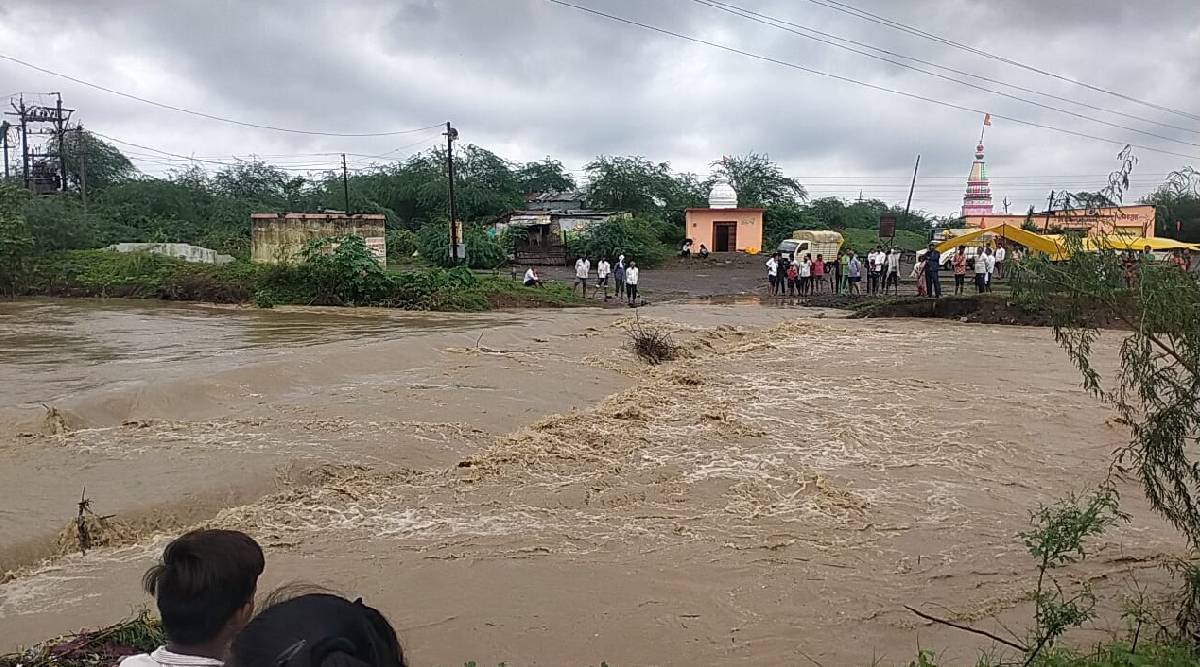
[142,530,265,645]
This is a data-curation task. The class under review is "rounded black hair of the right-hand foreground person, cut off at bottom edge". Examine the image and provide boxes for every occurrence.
[226,593,407,667]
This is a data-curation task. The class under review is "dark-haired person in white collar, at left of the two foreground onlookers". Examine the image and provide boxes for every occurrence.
[121,530,265,667]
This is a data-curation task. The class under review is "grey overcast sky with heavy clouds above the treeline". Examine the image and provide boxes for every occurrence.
[0,0,1200,214]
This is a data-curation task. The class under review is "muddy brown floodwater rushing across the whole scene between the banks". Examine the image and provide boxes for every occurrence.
[0,301,1182,665]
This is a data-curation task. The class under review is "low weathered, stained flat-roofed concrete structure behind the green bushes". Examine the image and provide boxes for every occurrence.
[250,214,388,265]
